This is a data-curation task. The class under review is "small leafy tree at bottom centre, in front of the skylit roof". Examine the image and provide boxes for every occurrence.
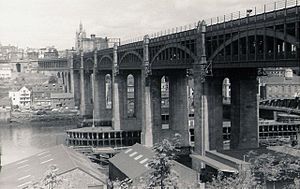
[148,134,181,189]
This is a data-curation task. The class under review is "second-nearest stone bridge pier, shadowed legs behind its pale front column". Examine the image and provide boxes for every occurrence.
[145,70,189,146]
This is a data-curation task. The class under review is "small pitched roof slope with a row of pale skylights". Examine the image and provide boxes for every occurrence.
[109,143,154,179]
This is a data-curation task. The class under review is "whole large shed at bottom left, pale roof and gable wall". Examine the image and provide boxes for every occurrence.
[0,145,107,189]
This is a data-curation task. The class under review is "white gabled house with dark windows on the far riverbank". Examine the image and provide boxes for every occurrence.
[9,86,31,108]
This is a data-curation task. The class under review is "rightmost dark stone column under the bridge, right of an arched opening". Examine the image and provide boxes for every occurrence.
[230,69,259,149]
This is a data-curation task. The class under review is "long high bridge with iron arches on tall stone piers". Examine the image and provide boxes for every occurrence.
[38,0,300,171]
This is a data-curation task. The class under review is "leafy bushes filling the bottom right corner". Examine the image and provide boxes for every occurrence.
[207,151,300,189]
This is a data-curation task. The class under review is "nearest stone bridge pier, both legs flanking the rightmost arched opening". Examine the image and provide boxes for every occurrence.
[192,68,259,170]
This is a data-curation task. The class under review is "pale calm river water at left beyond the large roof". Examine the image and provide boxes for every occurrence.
[0,121,76,165]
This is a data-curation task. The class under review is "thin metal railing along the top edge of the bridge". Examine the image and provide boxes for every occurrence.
[121,0,300,45]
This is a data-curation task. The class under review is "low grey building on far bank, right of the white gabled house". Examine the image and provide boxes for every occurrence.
[50,93,75,109]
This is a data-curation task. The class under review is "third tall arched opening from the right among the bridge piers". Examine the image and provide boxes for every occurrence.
[127,74,135,117]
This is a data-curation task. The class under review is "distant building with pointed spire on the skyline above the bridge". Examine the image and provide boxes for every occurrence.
[75,23,108,52]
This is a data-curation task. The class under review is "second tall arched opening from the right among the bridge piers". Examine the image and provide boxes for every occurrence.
[160,76,170,129]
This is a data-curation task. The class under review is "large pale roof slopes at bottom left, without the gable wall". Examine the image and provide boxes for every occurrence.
[0,145,106,188]
